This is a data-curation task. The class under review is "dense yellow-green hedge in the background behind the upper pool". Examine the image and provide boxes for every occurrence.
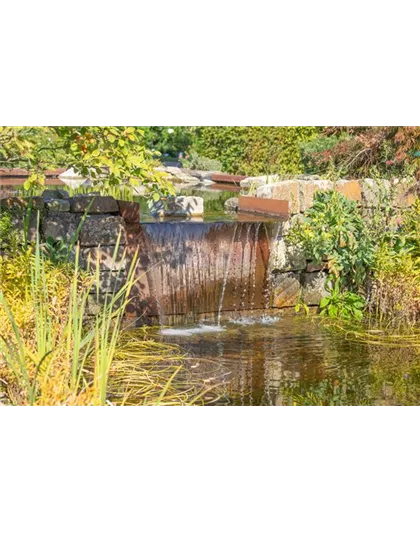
[194,126,321,176]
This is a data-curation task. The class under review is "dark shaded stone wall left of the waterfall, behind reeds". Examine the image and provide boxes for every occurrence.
[0,190,140,314]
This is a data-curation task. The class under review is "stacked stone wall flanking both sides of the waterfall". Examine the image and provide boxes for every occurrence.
[0,176,415,316]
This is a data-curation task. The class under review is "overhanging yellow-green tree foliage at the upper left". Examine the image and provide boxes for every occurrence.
[0,126,174,197]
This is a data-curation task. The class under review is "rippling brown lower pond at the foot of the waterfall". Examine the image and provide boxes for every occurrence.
[160,312,420,407]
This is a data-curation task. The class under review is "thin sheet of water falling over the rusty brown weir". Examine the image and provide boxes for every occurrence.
[136,221,276,325]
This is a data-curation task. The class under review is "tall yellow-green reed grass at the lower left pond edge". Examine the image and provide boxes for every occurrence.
[0,232,225,406]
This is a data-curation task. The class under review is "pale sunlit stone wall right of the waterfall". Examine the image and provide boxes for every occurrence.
[256,176,415,308]
